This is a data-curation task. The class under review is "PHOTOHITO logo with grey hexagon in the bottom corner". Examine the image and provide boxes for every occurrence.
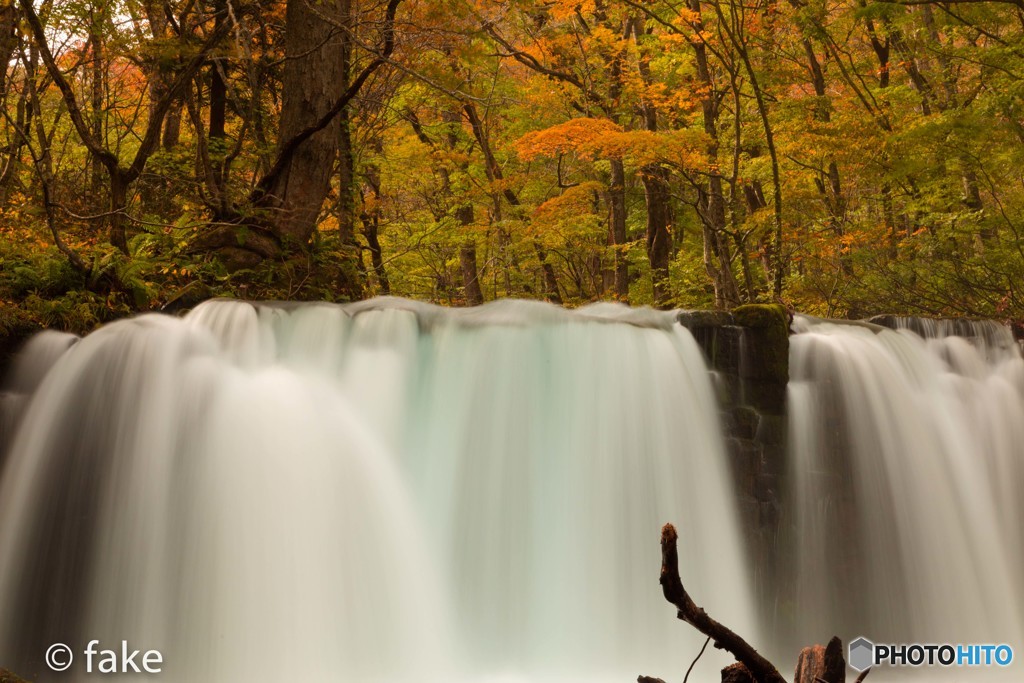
[847,636,1014,671]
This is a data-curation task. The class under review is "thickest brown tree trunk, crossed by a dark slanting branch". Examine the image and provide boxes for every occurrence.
[260,0,349,247]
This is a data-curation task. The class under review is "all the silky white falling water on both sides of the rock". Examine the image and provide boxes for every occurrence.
[0,299,1024,683]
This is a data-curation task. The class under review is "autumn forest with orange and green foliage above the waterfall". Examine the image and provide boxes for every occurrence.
[0,0,1024,331]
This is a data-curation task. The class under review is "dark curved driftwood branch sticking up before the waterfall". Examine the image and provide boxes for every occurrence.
[662,524,785,683]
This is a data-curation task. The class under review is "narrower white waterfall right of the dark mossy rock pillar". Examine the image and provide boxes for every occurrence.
[788,317,1024,679]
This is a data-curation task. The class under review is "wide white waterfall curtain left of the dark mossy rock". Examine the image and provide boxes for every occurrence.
[0,300,759,683]
